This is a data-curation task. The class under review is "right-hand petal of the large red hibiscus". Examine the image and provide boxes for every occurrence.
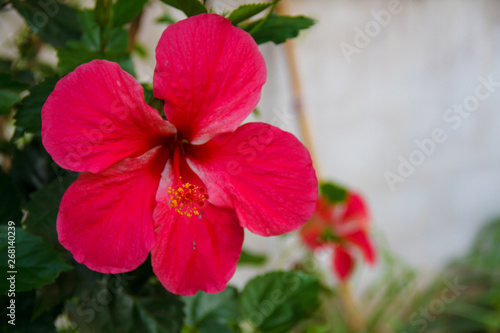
[187,123,318,236]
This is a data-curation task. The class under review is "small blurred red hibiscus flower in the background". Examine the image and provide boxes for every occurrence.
[300,188,375,281]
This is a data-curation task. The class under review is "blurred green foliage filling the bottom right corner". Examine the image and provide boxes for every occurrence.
[344,220,500,333]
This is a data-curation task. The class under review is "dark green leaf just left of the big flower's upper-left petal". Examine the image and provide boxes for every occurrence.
[14,77,59,134]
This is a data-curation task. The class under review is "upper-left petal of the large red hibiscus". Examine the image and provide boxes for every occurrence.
[42,60,175,173]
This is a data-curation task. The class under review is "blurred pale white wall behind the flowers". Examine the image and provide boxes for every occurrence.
[252,0,500,282]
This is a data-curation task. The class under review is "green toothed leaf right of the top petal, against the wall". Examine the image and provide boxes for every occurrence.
[242,14,314,44]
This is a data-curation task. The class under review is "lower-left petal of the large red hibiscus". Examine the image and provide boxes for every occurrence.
[57,147,168,274]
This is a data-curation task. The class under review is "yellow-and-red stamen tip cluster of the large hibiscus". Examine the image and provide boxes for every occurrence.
[168,183,208,217]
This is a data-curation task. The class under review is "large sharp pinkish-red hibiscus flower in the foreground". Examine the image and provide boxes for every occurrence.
[42,14,317,295]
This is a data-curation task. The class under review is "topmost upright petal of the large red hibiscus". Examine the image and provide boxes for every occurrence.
[153,14,267,144]
